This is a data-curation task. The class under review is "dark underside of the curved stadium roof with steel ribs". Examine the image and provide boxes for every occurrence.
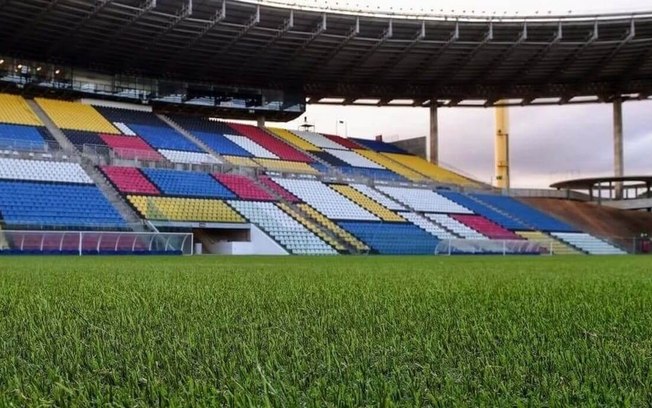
[0,0,652,106]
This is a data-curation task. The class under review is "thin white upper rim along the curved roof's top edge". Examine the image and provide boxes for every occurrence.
[236,0,652,22]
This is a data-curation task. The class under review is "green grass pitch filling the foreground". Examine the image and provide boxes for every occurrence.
[0,257,652,407]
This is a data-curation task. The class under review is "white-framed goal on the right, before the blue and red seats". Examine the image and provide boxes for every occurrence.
[435,239,553,255]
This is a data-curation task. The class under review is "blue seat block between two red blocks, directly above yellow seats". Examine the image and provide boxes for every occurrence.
[142,169,236,199]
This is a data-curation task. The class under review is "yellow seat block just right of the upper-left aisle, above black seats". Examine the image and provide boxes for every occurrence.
[35,98,121,135]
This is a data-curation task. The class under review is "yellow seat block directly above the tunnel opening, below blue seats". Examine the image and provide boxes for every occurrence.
[127,196,245,223]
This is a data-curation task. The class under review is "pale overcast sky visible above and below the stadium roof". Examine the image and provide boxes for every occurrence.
[256,0,652,187]
